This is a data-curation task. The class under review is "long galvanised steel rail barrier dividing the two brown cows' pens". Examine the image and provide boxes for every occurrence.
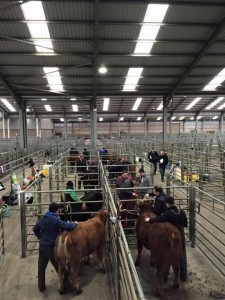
[100,163,146,300]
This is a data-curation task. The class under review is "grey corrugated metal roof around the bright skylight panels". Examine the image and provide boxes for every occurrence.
[0,0,225,120]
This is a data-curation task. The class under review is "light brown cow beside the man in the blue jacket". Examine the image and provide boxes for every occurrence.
[55,209,108,294]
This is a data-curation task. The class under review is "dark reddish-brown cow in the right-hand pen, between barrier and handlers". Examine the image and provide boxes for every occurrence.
[135,202,182,296]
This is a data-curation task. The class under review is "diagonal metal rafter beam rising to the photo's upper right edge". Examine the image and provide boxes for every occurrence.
[166,18,225,106]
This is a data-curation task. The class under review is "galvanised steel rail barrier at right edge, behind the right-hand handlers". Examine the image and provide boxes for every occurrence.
[167,169,225,276]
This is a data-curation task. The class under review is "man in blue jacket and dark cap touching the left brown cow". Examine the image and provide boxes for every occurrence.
[33,202,78,292]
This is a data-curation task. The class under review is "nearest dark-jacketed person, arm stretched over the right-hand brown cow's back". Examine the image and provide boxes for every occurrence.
[145,196,188,281]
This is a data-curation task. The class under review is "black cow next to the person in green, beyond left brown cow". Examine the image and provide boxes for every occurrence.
[60,191,103,222]
